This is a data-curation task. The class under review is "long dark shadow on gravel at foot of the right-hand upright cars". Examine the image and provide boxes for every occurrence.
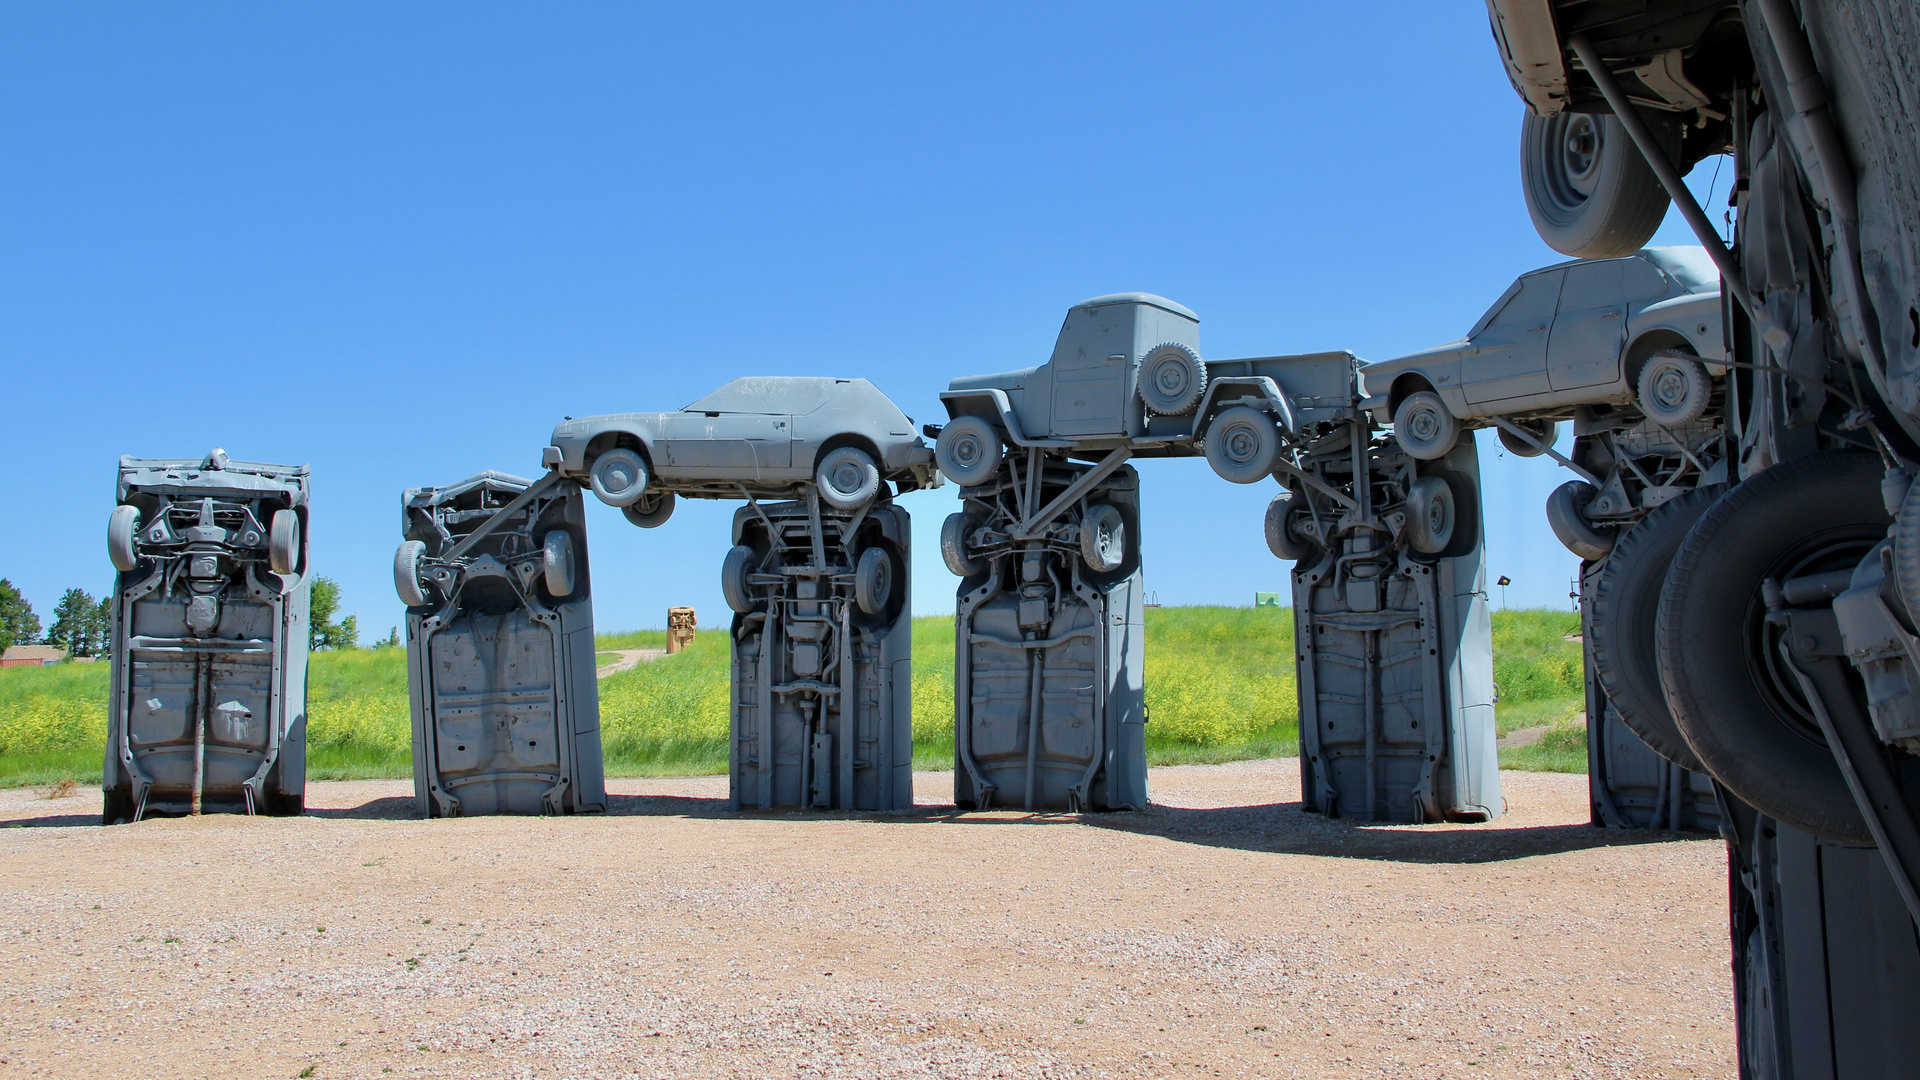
[1081,803,1718,863]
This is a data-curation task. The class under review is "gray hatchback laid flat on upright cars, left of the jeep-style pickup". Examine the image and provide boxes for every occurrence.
[545,375,941,528]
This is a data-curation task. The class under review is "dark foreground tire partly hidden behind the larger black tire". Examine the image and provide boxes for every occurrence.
[1588,484,1726,771]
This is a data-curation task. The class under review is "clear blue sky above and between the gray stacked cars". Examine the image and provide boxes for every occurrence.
[0,0,1726,638]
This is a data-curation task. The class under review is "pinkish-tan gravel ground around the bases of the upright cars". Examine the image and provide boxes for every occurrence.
[0,761,1734,1078]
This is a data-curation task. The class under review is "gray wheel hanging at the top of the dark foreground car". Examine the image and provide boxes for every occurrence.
[1521,111,1667,259]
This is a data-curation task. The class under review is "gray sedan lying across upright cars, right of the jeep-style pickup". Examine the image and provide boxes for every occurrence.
[1361,248,1726,459]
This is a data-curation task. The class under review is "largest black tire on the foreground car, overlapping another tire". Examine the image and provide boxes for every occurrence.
[1655,452,1887,844]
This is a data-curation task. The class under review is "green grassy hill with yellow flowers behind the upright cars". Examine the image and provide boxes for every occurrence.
[0,607,1586,784]
